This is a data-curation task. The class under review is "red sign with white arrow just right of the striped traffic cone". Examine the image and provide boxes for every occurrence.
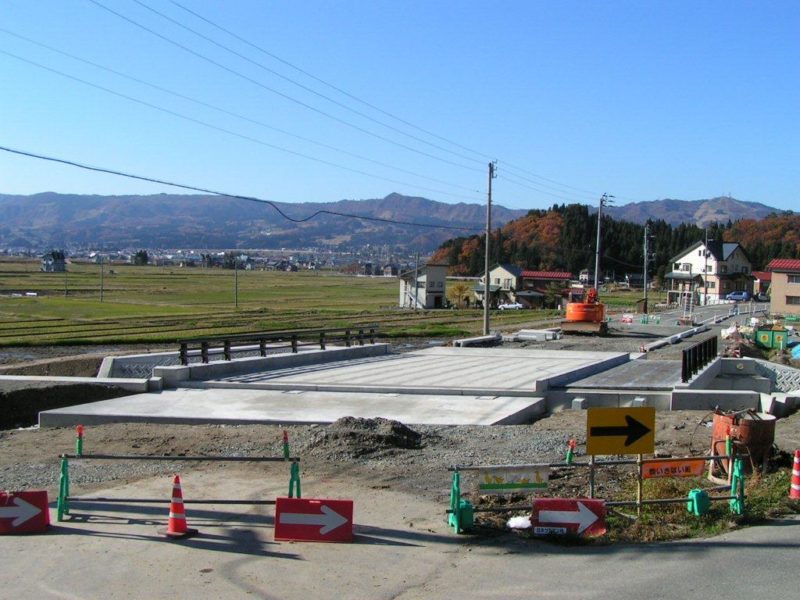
[275,498,353,542]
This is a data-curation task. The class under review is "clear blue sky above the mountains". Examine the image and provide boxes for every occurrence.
[0,0,800,210]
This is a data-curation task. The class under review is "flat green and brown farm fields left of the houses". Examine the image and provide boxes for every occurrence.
[0,261,555,347]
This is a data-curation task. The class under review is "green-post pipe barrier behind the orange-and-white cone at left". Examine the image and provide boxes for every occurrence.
[57,425,302,521]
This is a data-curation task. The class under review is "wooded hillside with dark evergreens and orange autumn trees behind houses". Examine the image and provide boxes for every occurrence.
[432,204,800,277]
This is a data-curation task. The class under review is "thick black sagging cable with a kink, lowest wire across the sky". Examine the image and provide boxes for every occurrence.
[0,146,481,231]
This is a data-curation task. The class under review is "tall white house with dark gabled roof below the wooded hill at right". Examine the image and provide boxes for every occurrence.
[664,241,753,305]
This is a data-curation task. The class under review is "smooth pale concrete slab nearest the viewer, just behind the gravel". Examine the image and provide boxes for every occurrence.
[39,389,545,427]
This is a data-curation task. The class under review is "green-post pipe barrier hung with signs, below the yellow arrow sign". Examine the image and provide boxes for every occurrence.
[446,454,745,533]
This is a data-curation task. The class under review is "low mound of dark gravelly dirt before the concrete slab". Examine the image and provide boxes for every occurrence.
[303,417,422,458]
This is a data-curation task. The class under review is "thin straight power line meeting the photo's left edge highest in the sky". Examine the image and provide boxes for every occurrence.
[0,27,479,193]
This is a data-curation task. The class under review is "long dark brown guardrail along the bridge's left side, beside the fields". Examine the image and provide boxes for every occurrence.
[178,325,378,366]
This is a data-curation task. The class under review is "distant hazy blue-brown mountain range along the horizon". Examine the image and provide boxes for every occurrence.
[0,192,779,252]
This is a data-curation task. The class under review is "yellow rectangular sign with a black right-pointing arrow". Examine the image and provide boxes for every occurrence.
[586,406,656,454]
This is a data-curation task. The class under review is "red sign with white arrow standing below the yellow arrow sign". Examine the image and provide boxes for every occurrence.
[531,498,606,537]
